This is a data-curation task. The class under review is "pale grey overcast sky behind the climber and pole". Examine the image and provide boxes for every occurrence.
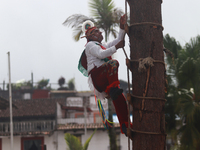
[0,0,200,91]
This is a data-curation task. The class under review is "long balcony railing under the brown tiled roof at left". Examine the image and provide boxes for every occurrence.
[0,120,55,133]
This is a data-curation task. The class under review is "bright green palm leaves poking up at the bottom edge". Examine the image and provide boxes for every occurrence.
[65,130,96,150]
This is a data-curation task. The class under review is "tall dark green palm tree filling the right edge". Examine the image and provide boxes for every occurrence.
[177,36,200,150]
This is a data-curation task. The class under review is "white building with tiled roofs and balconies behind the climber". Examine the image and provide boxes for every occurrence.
[0,93,131,150]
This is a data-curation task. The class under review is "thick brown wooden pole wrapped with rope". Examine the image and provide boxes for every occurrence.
[128,0,166,150]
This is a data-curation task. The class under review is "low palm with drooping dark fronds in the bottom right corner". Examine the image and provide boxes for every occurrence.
[177,89,200,150]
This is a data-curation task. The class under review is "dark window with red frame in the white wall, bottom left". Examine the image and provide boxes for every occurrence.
[21,137,44,150]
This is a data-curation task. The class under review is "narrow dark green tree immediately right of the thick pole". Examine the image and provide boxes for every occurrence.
[163,34,182,131]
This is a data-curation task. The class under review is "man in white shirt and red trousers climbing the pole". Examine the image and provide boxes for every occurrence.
[79,15,131,135]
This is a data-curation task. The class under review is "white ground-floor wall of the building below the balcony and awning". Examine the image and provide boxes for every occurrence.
[0,130,132,150]
